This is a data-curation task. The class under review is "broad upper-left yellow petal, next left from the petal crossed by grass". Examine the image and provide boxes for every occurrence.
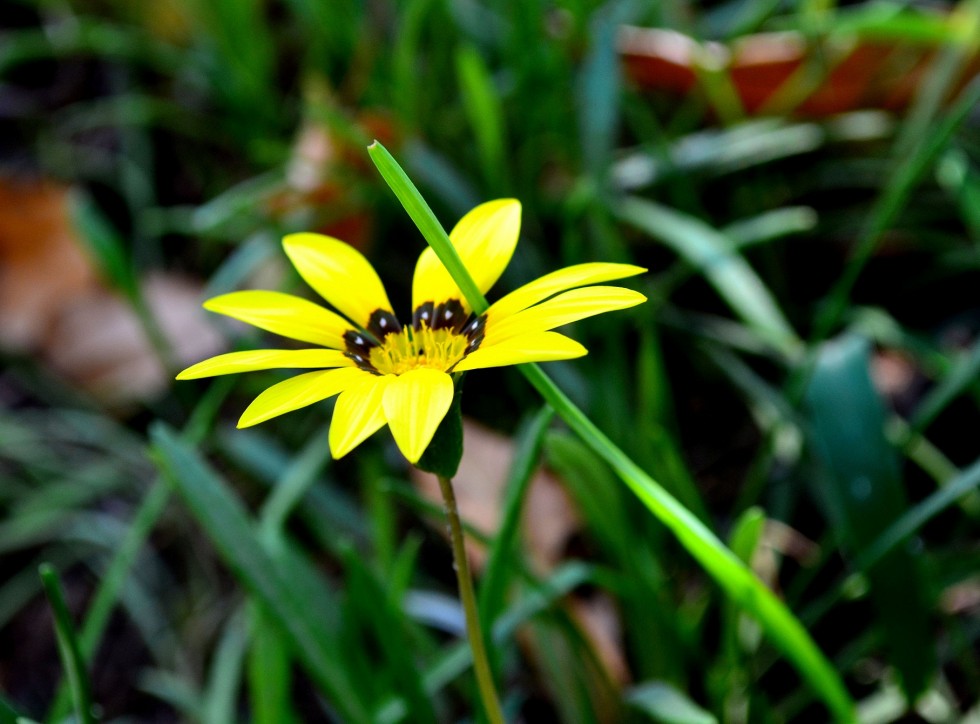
[282,233,391,327]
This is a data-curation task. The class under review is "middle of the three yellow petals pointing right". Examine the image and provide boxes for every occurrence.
[483,287,646,345]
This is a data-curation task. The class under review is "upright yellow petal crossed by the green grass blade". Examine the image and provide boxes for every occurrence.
[412,199,521,309]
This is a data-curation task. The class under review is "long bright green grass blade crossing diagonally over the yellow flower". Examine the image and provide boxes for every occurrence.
[368,142,856,722]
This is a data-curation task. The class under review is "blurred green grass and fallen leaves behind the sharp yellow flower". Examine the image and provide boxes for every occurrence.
[0,0,980,724]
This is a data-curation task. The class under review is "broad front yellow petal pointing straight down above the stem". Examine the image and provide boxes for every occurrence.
[383,367,453,465]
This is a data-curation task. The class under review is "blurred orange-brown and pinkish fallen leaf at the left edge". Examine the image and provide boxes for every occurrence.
[0,173,223,406]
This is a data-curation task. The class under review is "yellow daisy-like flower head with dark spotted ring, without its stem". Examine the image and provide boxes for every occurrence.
[177,199,646,463]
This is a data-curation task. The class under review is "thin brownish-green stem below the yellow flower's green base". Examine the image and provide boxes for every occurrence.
[437,475,504,724]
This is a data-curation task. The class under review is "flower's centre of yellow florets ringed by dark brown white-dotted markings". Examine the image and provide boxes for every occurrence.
[344,300,486,375]
